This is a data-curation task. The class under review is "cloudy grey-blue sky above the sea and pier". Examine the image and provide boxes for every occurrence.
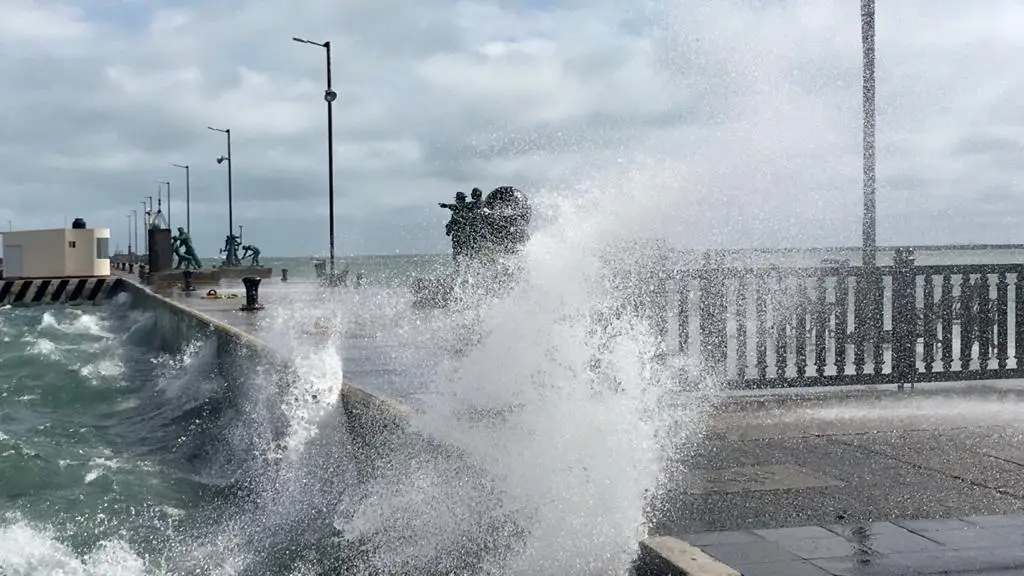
[0,0,1024,255]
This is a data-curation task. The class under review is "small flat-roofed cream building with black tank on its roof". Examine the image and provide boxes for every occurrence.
[2,222,111,279]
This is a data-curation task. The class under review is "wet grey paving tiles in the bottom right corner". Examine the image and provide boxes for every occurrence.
[680,515,1024,576]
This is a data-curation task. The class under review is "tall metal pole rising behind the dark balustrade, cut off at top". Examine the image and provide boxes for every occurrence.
[860,0,877,265]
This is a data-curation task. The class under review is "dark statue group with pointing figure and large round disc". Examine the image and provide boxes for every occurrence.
[437,187,530,269]
